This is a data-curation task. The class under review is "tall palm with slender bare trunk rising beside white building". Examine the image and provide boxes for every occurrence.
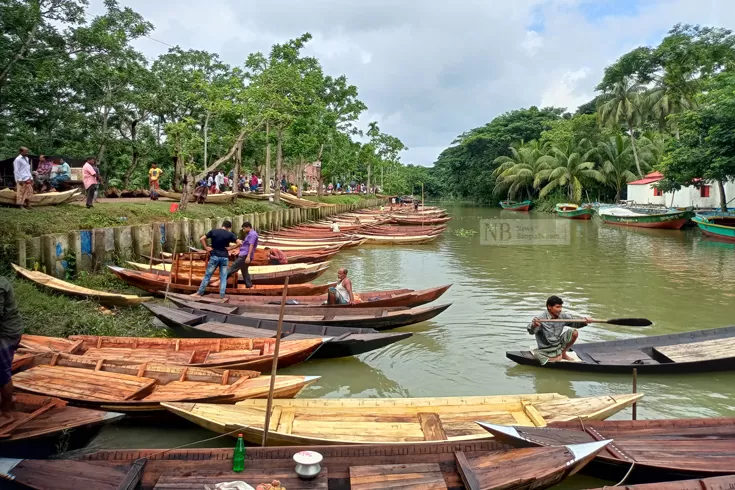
[597,77,645,178]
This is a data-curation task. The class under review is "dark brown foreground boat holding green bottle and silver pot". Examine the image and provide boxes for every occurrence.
[0,441,609,490]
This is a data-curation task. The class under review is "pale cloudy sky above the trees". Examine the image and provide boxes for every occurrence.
[90,0,735,166]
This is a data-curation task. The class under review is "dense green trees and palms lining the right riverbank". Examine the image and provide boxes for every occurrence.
[431,25,735,206]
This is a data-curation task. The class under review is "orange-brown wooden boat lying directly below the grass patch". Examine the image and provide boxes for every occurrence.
[21,335,322,372]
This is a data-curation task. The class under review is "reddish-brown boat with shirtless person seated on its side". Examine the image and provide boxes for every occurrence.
[167,284,452,309]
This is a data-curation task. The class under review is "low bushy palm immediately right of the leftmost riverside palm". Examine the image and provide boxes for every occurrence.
[537,140,605,202]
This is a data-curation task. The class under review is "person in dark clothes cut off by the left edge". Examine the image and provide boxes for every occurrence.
[0,276,23,426]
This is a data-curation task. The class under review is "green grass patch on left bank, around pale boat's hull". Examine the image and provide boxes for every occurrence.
[11,274,162,337]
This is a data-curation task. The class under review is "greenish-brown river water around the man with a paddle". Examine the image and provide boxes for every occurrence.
[83,206,735,488]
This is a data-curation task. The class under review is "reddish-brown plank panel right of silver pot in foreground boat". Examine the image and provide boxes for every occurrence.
[350,463,447,490]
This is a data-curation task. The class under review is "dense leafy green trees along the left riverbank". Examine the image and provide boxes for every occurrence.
[0,0,420,203]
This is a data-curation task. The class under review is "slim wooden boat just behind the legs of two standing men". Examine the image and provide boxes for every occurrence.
[144,259,331,288]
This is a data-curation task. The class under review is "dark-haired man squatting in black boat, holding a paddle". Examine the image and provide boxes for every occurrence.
[528,296,592,366]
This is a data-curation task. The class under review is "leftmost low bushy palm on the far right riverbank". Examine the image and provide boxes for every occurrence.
[493,140,546,199]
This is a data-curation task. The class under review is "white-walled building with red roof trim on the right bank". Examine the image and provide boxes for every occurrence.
[628,172,735,208]
